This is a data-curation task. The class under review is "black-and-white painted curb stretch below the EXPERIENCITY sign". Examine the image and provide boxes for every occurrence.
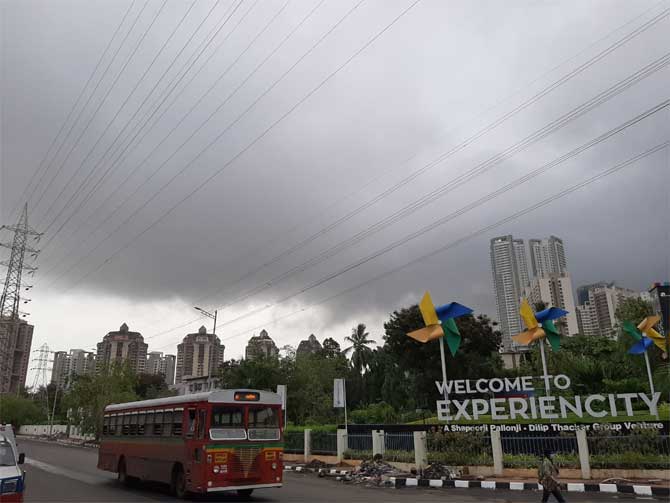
[388,477,670,497]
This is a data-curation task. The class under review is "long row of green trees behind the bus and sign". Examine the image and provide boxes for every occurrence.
[0,299,670,432]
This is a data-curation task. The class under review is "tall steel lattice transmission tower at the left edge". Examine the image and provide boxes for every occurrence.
[0,203,42,393]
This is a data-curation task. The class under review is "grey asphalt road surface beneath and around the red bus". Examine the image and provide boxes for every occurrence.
[19,439,635,503]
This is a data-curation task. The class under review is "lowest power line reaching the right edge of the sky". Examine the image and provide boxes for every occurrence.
[157,141,670,349]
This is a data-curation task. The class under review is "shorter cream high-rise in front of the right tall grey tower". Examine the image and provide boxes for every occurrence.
[524,273,579,336]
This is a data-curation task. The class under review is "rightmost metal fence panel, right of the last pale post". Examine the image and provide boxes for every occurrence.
[586,431,670,470]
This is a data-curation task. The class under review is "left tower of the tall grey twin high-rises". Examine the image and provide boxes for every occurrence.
[491,235,528,351]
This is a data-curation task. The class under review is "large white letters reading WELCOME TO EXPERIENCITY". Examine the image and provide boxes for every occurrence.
[435,374,661,421]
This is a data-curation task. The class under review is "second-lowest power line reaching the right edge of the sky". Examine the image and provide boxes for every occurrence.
[147,100,670,339]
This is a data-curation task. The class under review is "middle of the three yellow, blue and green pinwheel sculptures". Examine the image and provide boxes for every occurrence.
[512,299,568,391]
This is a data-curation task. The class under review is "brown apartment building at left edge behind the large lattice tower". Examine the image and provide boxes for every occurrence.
[0,318,33,394]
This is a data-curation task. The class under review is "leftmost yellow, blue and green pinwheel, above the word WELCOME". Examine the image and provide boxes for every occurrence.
[407,292,472,399]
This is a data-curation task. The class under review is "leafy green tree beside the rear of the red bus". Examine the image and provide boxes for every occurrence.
[65,365,139,438]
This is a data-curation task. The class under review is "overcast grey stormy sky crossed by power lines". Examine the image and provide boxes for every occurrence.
[0,0,670,358]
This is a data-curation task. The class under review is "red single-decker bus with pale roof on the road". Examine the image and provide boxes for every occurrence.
[98,389,284,497]
